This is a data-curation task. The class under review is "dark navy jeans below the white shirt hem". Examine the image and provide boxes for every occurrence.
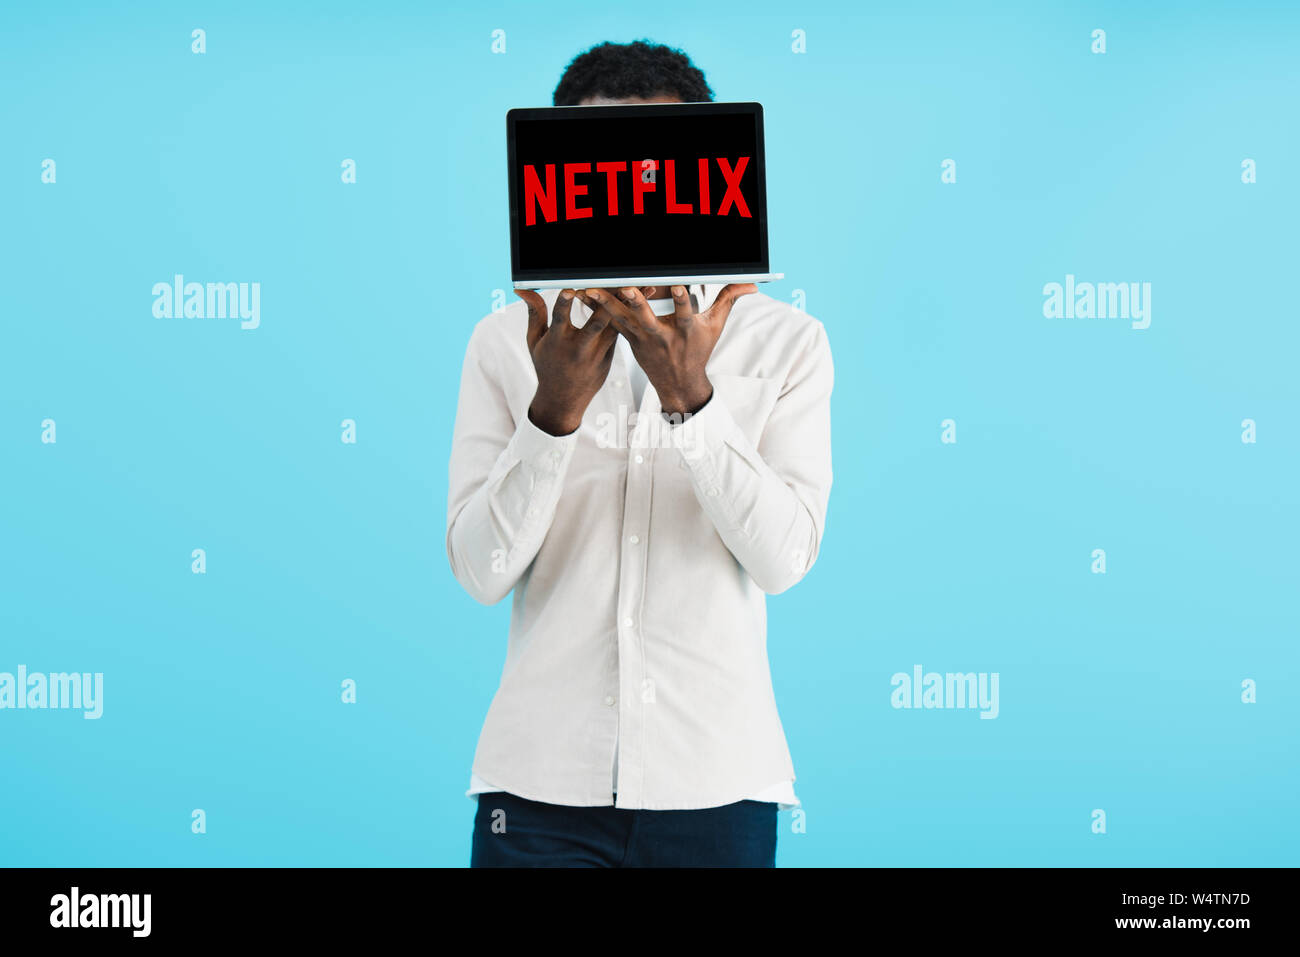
[469,791,776,867]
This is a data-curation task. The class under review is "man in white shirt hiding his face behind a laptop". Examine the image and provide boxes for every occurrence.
[447,42,832,867]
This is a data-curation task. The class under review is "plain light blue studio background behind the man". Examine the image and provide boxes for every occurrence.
[0,0,1300,866]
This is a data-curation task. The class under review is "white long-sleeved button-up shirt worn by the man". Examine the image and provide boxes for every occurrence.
[447,286,833,810]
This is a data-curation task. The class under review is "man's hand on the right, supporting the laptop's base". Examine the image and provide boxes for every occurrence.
[581,282,758,415]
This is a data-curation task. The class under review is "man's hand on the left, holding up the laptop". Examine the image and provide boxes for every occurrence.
[516,289,619,436]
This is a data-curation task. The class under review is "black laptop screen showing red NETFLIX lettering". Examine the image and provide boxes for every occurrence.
[506,103,767,282]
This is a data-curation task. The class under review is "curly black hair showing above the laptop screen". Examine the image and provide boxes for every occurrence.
[553,40,714,107]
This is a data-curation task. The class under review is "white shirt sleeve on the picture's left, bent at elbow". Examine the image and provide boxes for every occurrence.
[447,326,577,605]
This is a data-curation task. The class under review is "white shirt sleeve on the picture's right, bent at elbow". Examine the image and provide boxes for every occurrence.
[675,322,835,594]
